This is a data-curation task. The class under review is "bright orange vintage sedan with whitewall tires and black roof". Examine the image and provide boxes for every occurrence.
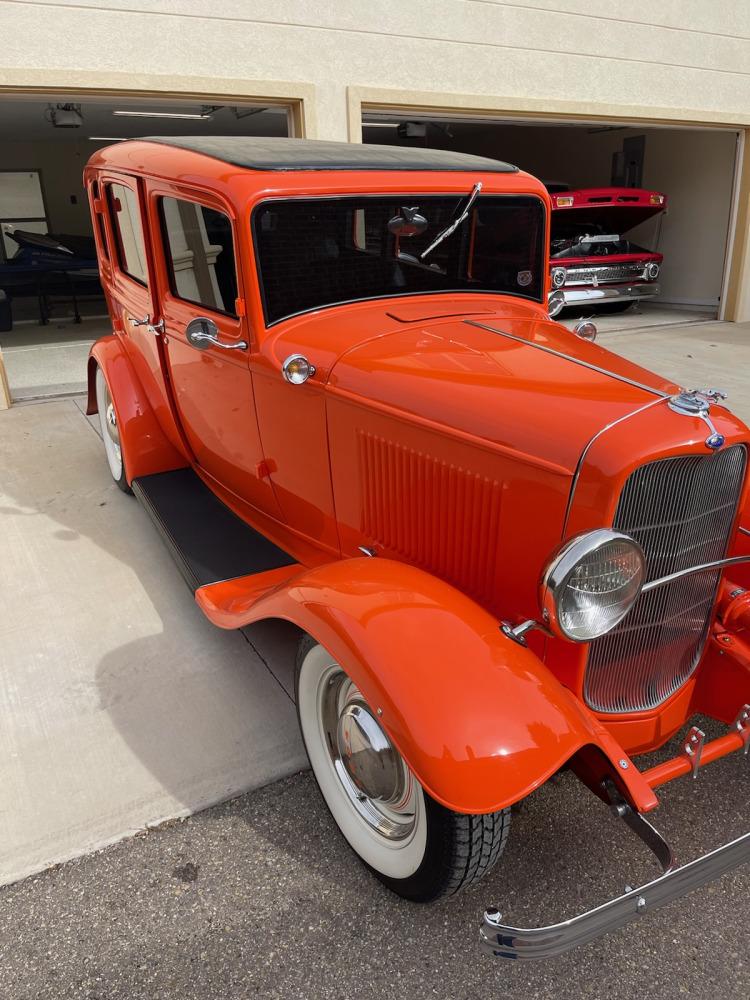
[85,138,750,959]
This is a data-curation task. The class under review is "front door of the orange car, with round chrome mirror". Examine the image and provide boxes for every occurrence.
[149,184,279,517]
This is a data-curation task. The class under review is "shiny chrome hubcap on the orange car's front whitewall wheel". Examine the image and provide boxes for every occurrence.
[318,665,418,841]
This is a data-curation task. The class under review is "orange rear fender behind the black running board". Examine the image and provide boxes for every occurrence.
[86,334,188,484]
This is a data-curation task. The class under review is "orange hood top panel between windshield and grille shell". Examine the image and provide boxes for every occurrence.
[329,313,678,474]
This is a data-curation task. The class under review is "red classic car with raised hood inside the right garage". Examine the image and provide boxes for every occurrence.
[550,185,667,316]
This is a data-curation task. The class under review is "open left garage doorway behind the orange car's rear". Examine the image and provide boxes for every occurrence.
[0,94,293,401]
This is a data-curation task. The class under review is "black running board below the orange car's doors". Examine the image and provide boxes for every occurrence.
[131,469,295,593]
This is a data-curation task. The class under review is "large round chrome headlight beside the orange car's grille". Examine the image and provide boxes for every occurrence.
[540,528,646,642]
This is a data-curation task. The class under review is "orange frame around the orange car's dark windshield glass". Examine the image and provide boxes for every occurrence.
[249,188,550,330]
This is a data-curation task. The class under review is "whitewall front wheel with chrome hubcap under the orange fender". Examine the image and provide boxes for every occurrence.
[296,636,510,903]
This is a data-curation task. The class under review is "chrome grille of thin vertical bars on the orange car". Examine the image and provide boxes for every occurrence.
[584,445,746,712]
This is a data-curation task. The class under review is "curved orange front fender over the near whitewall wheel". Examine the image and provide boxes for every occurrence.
[196,558,656,813]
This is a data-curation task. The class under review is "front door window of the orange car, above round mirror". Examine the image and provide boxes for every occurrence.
[160,198,237,316]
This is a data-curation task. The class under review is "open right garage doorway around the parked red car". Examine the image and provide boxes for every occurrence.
[362,109,739,330]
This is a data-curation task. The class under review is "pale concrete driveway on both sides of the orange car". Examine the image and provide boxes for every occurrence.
[0,323,750,884]
